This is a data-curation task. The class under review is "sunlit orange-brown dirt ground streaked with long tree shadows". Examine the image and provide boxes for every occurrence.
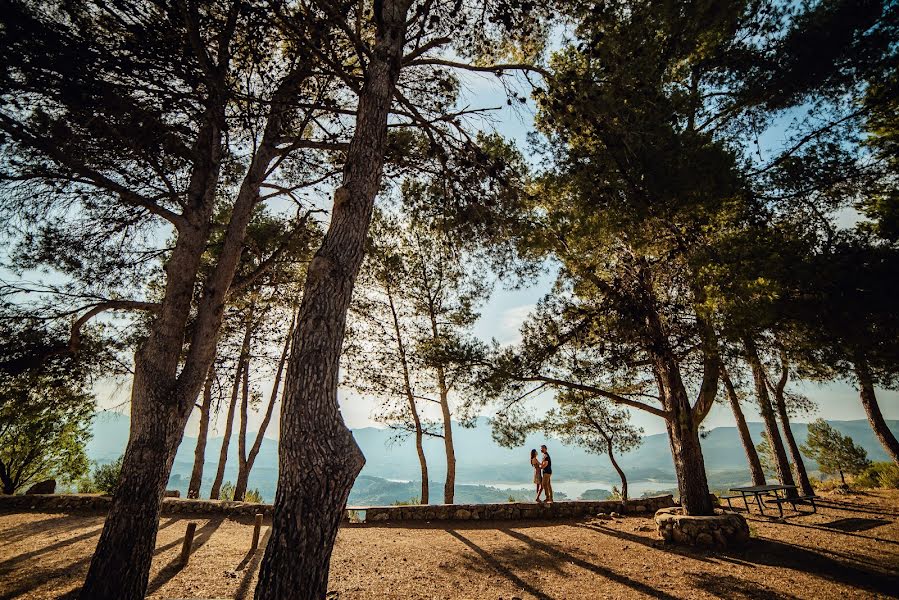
[0,492,899,600]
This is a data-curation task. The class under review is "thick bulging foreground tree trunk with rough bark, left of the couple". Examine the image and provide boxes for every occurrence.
[256,0,410,600]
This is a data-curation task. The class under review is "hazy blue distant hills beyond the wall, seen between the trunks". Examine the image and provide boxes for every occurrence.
[87,412,899,504]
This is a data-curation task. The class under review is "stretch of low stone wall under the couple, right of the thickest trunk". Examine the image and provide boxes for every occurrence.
[357,495,675,523]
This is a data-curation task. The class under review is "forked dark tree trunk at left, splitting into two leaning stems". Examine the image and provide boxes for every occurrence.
[79,34,312,600]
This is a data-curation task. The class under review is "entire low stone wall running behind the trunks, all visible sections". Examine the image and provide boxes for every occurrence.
[0,494,675,523]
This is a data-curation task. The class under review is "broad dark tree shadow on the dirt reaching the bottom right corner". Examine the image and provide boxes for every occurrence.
[716,538,899,594]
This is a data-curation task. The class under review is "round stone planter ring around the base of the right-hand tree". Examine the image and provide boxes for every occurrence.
[655,506,749,548]
